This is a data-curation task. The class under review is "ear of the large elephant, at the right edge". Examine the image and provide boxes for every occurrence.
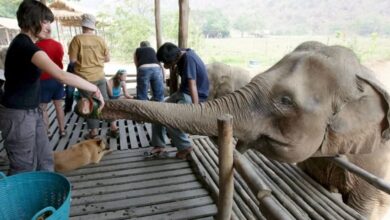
[316,67,390,156]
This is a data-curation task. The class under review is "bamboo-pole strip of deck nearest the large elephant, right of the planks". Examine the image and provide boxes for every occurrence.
[192,136,364,220]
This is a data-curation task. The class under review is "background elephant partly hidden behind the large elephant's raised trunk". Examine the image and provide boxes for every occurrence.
[206,62,252,100]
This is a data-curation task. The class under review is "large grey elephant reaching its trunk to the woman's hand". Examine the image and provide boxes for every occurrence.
[78,41,390,219]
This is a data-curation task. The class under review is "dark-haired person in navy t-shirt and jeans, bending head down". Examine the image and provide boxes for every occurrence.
[151,42,209,160]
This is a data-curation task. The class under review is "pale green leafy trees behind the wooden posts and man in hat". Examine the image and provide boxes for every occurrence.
[98,0,202,62]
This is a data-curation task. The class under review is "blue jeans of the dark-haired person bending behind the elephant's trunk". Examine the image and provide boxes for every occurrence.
[152,92,192,151]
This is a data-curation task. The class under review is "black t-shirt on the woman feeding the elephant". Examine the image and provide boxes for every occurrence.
[1,34,41,109]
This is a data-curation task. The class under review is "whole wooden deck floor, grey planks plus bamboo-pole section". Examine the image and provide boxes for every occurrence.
[0,104,362,220]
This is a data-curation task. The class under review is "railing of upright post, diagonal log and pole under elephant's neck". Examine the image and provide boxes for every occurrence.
[217,115,390,220]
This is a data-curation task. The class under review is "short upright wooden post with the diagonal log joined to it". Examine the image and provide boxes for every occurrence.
[217,115,291,220]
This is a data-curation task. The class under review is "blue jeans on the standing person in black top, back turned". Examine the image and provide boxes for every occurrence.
[137,67,164,102]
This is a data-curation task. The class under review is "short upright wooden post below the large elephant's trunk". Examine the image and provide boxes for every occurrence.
[218,115,234,220]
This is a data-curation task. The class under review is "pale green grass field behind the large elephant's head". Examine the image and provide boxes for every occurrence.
[194,35,390,70]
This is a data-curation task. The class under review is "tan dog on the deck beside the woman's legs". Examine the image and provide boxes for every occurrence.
[54,139,111,173]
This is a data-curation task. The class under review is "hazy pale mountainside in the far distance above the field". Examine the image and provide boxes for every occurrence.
[78,0,390,35]
